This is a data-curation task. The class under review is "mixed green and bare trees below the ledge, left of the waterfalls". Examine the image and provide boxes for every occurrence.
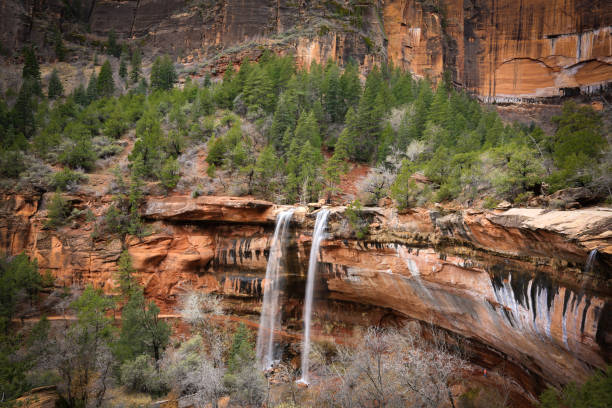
[0,252,267,408]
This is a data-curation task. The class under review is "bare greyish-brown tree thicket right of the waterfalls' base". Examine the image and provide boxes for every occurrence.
[316,326,465,408]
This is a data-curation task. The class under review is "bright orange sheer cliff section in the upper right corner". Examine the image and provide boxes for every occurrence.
[384,0,612,101]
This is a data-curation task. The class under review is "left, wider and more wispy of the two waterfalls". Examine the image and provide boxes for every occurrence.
[256,210,293,370]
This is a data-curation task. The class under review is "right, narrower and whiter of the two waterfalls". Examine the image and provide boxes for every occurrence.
[298,209,329,384]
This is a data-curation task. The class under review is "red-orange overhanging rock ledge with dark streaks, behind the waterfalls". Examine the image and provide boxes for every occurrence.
[0,196,612,395]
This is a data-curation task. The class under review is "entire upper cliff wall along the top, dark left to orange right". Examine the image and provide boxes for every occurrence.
[0,0,612,102]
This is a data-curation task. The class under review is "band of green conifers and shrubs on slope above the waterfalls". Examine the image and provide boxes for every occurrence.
[0,49,611,207]
